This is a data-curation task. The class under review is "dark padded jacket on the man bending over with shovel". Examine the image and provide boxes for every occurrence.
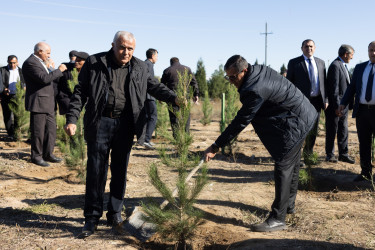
[215,65,318,161]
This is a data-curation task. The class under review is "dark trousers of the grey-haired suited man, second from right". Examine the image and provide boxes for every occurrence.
[325,107,349,158]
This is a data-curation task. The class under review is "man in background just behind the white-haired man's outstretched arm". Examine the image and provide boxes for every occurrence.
[137,49,158,149]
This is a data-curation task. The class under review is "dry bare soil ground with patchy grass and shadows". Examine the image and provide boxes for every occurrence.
[0,102,375,249]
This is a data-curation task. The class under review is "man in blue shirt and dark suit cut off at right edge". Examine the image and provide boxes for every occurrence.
[337,41,375,181]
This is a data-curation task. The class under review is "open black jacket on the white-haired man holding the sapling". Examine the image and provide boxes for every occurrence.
[66,49,176,141]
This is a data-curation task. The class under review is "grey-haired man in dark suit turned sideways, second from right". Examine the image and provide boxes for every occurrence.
[325,44,355,164]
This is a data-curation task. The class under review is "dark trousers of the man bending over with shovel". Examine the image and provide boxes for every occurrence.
[270,140,303,221]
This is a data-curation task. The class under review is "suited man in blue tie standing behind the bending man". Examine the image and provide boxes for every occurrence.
[286,39,328,160]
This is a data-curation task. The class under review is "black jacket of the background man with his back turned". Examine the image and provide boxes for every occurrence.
[160,62,199,96]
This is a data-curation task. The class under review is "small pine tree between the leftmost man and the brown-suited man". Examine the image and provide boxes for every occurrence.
[9,81,30,142]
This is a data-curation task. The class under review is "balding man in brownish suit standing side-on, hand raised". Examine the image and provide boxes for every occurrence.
[22,42,66,167]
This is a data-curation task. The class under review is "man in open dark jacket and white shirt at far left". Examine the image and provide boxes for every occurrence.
[0,55,25,141]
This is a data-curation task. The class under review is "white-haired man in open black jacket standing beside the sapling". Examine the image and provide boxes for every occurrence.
[65,31,177,237]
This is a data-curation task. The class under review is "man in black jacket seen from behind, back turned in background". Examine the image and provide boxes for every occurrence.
[160,57,199,137]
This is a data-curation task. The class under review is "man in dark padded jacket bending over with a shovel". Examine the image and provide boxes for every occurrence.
[204,55,318,232]
